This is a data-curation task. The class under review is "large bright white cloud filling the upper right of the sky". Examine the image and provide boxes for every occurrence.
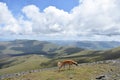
[72,0,120,33]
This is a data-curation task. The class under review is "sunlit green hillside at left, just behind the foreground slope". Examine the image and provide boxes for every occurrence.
[0,55,49,75]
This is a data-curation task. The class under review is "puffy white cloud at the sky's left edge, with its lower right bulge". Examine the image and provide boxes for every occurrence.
[0,2,32,35]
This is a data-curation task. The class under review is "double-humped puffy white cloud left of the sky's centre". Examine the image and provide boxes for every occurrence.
[22,5,69,34]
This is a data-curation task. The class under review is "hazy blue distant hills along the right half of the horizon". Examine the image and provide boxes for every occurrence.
[49,40,120,50]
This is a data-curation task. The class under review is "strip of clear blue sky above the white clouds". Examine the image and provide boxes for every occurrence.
[0,0,79,15]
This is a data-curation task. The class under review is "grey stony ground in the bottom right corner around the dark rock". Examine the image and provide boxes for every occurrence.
[89,59,120,80]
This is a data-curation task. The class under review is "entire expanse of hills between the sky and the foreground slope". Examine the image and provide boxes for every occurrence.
[0,40,120,75]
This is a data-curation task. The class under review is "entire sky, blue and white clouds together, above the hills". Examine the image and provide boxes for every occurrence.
[0,0,120,41]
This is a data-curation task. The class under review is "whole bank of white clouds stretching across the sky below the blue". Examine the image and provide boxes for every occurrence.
[0,0,120,40]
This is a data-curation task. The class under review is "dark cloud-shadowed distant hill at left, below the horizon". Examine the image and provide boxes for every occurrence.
[0,40,83,57]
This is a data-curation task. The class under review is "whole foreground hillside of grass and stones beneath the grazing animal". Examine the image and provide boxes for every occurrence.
[4,62,120,80]
